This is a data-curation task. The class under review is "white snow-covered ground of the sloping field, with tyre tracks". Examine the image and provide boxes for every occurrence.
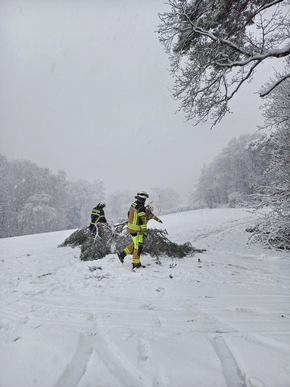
[0,209,290,387]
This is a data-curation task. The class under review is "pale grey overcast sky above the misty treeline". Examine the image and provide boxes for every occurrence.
[0,0,274,200]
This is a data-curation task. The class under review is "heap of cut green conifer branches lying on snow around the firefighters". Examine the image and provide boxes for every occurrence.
[58,224,205,261]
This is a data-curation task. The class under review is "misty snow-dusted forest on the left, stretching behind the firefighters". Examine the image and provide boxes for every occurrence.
[0,154,180,238]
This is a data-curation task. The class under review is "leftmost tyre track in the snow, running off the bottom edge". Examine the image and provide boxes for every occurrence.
[54,334,95,387]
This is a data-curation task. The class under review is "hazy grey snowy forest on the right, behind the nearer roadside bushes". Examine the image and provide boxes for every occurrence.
[193,134,268,208]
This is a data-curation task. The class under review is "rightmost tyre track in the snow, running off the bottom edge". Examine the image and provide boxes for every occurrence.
[209,335,247,387]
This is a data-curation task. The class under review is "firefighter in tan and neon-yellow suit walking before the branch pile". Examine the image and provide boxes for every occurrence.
[118,191,149,269]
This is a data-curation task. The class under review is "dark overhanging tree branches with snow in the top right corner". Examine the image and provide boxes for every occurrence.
[158,0,290,126]
